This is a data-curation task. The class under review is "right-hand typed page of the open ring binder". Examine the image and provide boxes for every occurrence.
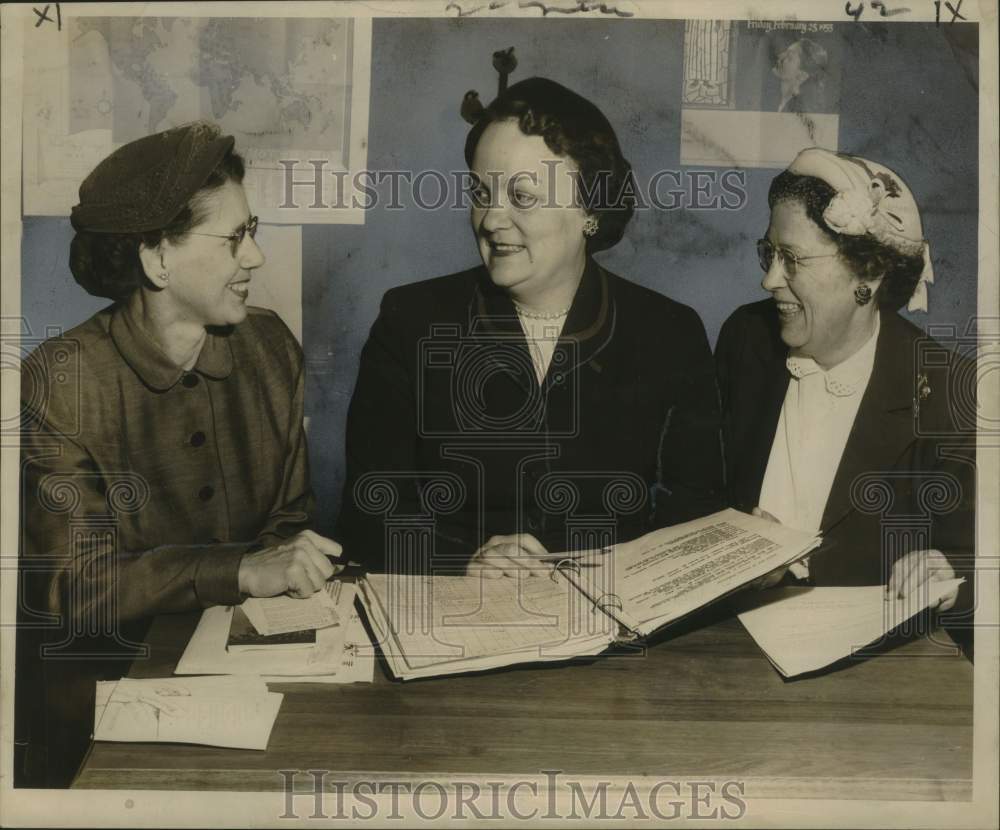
[606,509,819,634]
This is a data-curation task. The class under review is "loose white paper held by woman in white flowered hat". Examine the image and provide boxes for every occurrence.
[739,579,963,677]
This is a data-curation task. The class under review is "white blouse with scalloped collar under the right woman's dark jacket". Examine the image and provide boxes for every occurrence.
[760,316,880,578]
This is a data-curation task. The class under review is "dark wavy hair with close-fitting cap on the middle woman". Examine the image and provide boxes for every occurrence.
[465,78,635,254]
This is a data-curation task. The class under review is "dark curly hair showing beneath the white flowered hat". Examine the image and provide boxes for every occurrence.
[767,170,924,311]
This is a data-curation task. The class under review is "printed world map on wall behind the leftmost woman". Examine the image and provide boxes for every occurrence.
[68,17,351,158]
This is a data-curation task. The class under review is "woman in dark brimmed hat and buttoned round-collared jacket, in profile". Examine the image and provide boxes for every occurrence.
[16,124,340,785]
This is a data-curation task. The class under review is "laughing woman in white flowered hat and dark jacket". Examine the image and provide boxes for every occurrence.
[716,148,975,632]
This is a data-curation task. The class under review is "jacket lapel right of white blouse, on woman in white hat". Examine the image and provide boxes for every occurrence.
[821,312,916,533]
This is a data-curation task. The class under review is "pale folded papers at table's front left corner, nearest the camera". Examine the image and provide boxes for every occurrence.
[94,677,282,749]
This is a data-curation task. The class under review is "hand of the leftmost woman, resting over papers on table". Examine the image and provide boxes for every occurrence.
[239,530,344,599]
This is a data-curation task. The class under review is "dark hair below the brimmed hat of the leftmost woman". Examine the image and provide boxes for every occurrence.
[69,150,245,302]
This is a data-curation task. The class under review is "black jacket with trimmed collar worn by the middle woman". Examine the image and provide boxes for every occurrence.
[337,260,722,571]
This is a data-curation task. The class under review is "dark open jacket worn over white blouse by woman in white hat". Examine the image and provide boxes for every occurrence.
[716,300,976,596]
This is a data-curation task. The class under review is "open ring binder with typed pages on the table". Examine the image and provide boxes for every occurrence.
[360,509,820,680]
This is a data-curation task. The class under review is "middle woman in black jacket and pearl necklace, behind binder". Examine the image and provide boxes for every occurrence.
[338,78,721,576]
